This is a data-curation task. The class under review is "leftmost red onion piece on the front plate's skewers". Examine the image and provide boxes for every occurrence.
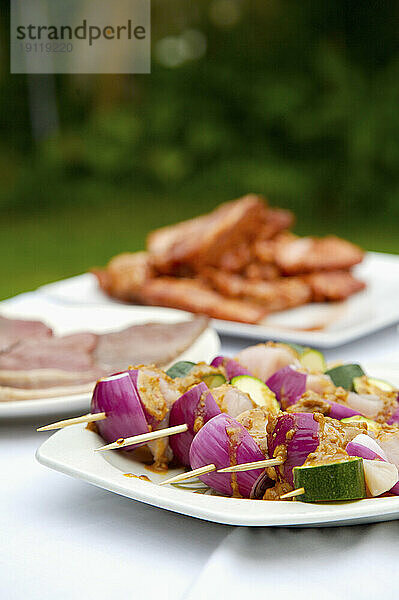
[91,372,148,447]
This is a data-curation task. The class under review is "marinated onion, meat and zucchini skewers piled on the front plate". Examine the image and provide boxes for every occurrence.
[39,343,399,502]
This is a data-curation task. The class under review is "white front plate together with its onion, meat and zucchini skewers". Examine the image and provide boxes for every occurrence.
[37,342,399,526]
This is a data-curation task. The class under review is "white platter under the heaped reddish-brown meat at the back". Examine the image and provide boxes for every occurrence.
[40,252,399,348]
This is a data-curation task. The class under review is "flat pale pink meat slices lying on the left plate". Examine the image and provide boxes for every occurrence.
[0,317,208,401]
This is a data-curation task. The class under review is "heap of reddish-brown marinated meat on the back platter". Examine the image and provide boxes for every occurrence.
[93,194,365,324]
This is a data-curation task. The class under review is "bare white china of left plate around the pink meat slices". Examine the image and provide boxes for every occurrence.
[0,293,220,419]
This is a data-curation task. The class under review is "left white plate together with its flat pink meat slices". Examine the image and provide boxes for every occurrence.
[0,294,219,418]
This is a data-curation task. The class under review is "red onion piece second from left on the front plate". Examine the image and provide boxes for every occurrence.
[169,382,221,466]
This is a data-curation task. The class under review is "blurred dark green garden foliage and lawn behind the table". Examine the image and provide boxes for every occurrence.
[0,0,399,298]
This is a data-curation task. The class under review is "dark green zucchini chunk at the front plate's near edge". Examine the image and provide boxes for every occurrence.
[293,458,366,502]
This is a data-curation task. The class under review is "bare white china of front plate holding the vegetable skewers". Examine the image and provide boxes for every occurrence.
[36,365,399,527]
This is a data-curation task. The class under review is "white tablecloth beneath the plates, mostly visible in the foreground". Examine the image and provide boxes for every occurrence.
[0,284,399,600]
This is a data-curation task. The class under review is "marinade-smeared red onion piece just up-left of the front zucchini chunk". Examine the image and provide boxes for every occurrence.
[267,413,319,485]
